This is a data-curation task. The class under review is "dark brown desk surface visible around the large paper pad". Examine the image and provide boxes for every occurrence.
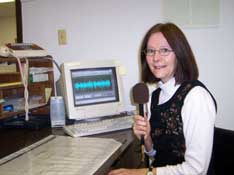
[0,128,141,175]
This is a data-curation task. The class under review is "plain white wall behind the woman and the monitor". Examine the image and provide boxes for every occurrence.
[22,0,234,130]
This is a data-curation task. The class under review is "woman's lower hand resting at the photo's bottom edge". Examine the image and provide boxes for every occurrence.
[108,168,147,175]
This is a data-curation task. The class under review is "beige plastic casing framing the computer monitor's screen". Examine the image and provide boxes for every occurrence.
[60,60,124,120]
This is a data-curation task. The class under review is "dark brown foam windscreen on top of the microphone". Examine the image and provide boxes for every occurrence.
[132,83,149,104]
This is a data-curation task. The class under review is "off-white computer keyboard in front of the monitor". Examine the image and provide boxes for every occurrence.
[63,115,133,137]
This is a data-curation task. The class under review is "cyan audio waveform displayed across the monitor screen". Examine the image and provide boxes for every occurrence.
[74,80,111,90]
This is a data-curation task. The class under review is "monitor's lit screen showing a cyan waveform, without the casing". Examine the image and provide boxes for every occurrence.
[71,67,119,106]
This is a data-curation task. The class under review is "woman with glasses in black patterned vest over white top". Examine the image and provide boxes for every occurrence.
[109,23,216,175]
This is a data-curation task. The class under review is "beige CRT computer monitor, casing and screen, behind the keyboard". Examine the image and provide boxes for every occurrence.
[60,60,123,120]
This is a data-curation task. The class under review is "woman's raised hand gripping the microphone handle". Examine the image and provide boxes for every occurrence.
[133,115,151,140]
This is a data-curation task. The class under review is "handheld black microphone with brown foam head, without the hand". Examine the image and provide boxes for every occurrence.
[132,83,149,145]
